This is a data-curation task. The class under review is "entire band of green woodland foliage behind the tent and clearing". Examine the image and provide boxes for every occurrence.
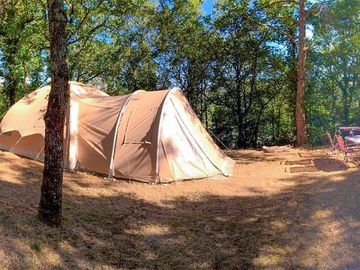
[0,0,360,147]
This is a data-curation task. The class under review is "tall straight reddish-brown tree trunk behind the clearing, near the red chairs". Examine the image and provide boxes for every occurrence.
[295,0,306,147]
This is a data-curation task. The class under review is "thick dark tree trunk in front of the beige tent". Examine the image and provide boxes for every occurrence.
[38,0,69,225]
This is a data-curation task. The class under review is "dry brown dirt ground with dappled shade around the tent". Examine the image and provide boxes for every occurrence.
[0,150,360,269]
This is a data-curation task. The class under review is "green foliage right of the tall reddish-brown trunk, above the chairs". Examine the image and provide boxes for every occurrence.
[306,0,360,144]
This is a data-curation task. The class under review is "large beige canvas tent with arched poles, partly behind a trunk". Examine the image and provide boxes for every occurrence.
[0,82,233,183]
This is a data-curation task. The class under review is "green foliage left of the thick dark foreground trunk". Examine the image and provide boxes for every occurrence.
[0,0,46,108]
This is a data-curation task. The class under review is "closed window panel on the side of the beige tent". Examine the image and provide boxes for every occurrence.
[124,107,158,144]
